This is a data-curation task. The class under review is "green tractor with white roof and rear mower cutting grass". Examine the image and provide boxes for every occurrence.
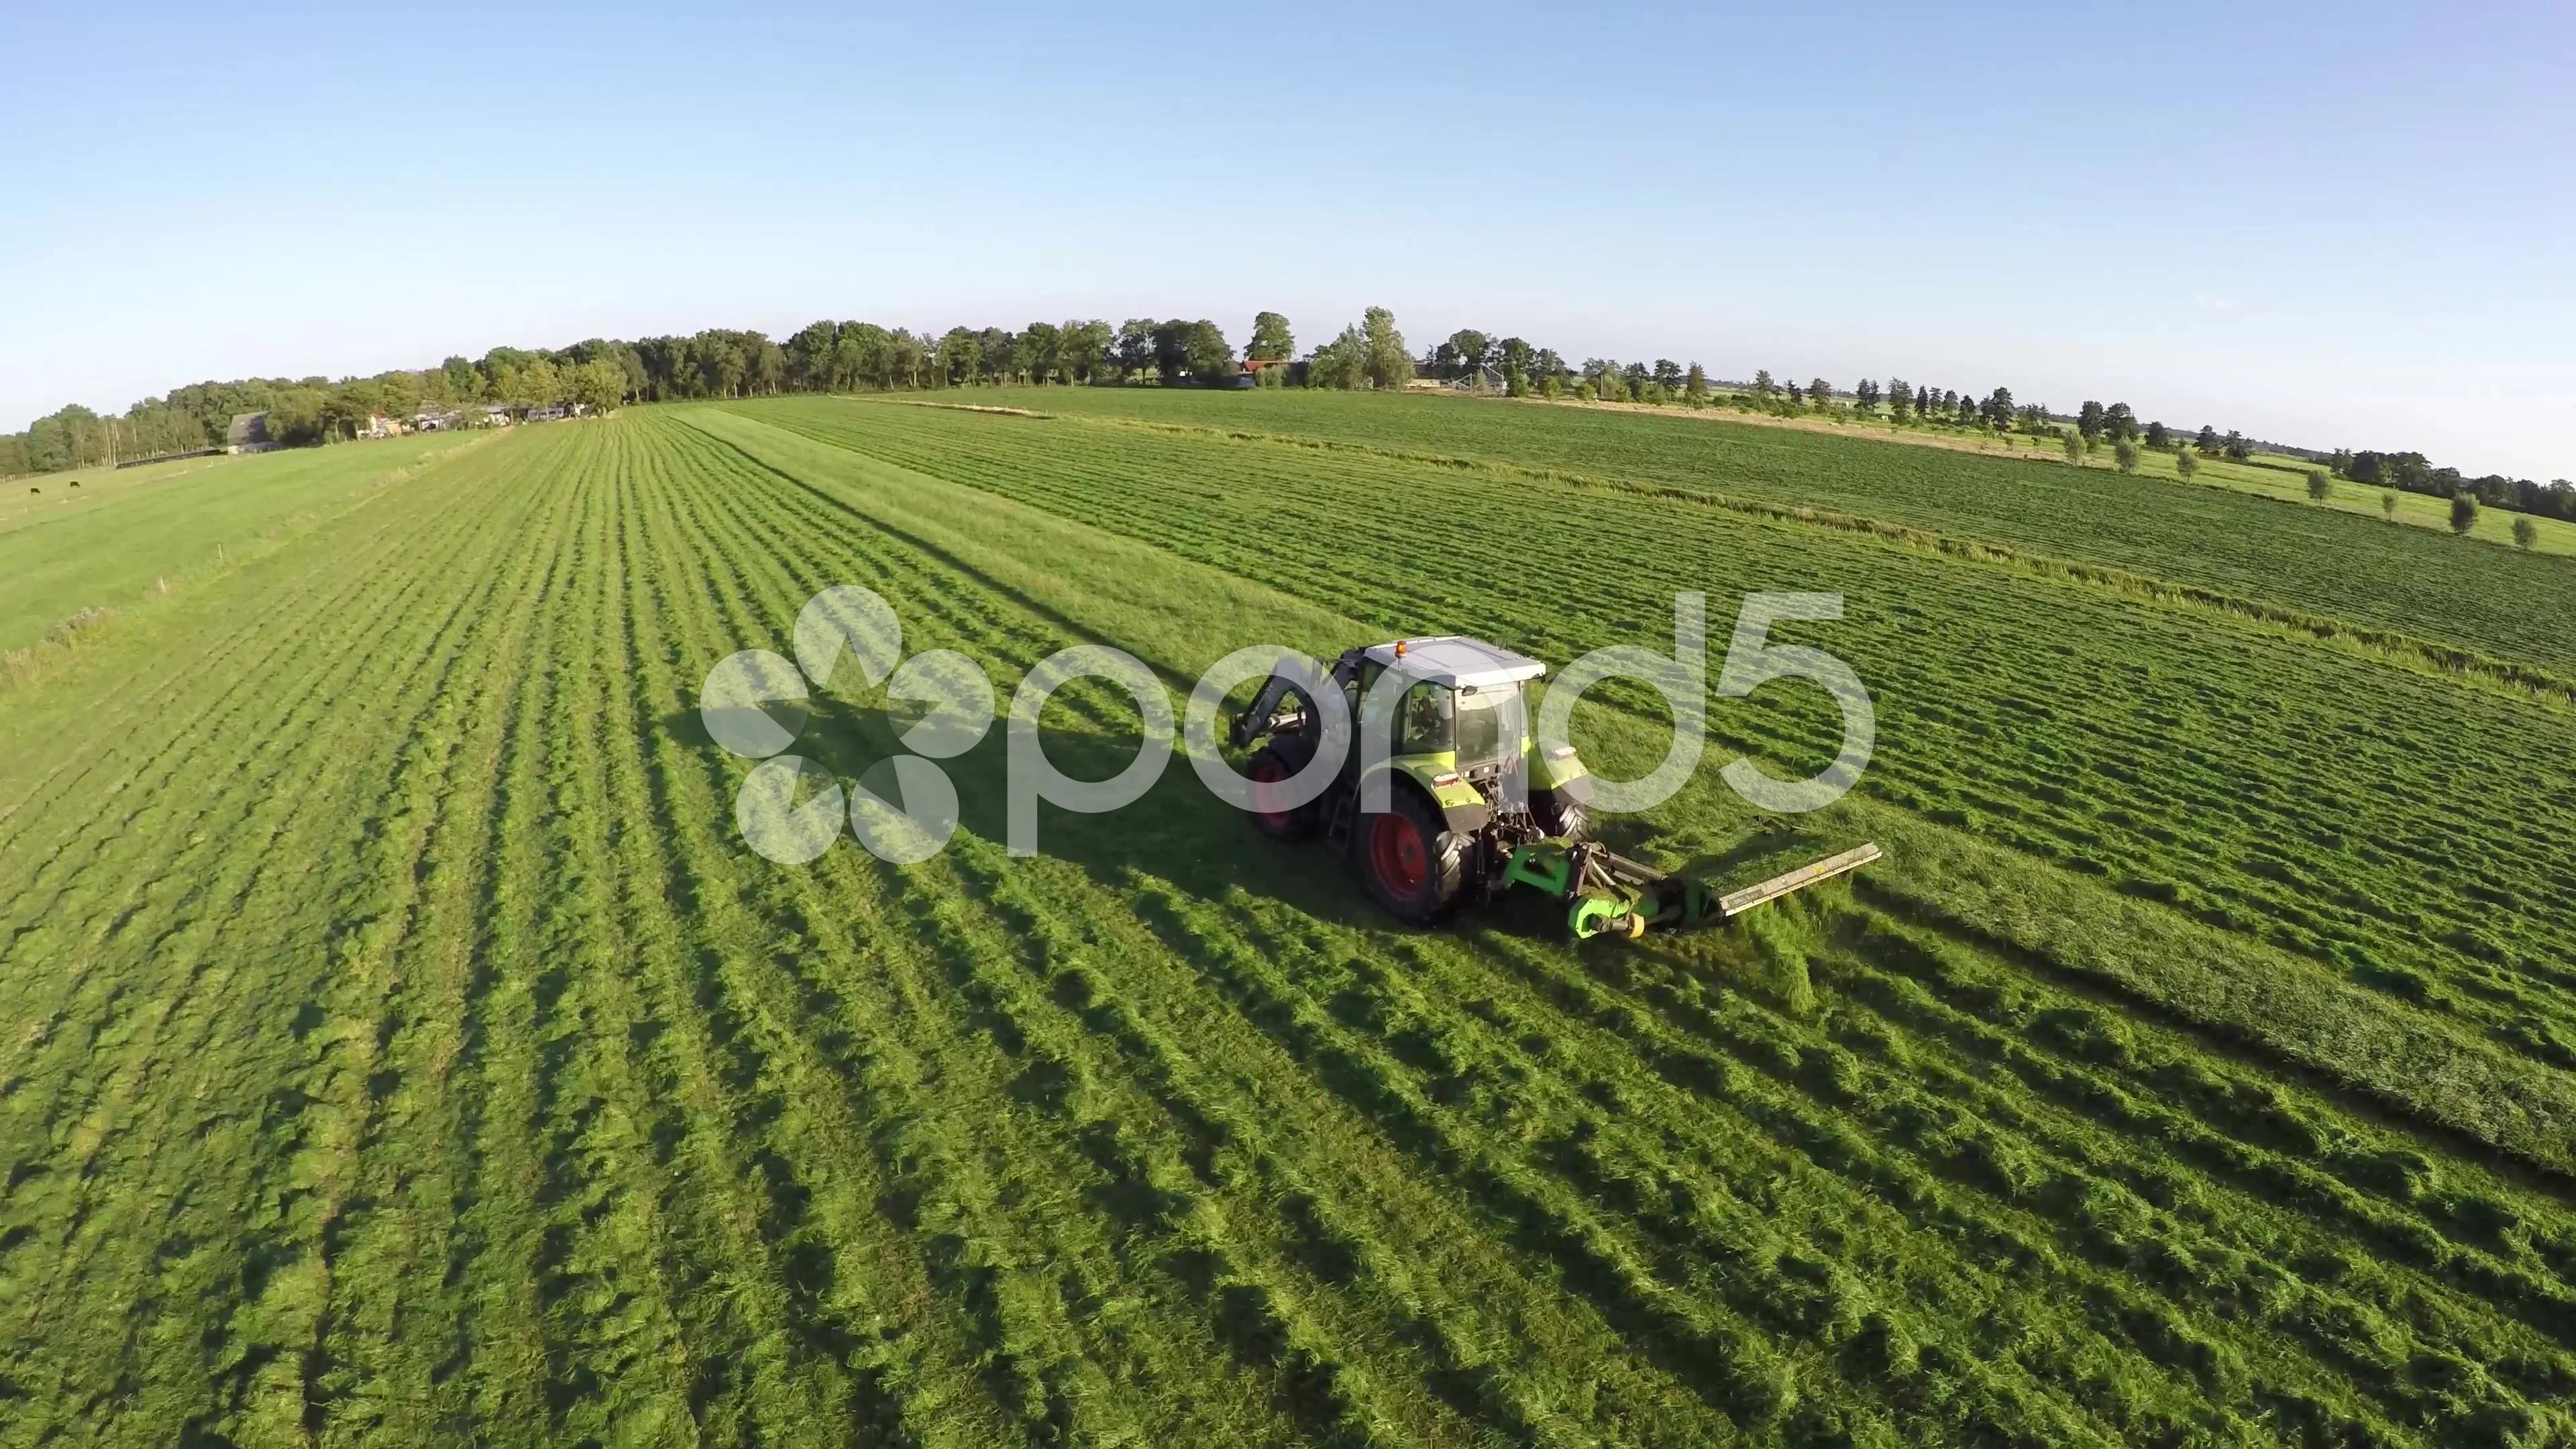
[1229,634,1878,938]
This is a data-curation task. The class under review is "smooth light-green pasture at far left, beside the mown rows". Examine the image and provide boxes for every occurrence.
[0,436,484,652]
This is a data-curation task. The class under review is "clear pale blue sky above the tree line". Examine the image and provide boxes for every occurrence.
[0,0,2576,477]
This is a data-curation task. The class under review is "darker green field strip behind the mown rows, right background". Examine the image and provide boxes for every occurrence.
[963,387,2576,676]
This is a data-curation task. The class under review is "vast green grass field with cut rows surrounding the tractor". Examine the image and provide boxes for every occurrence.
[0,389,2576,1449]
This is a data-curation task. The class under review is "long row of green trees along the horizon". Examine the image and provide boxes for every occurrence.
[0,307,2576,521]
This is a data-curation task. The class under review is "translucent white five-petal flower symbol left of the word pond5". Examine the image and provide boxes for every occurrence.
[698,583,994,866]
